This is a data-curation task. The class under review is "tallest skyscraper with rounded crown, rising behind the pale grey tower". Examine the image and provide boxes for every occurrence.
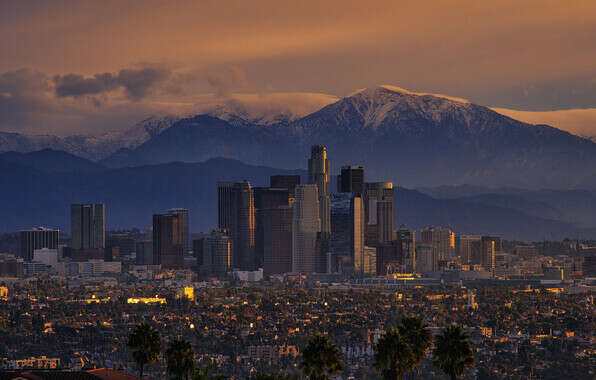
[308,145,331,237]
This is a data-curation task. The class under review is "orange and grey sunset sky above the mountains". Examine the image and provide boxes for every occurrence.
[0,0,596,136]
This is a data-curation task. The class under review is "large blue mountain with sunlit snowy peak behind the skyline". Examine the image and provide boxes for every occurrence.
[105,86,596,187]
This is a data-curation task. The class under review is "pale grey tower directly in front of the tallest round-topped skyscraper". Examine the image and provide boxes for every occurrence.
[292,184,325,273]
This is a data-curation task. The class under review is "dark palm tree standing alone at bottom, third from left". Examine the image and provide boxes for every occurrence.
[300,334,344,380]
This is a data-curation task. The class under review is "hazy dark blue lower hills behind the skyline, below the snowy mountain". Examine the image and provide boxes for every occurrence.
[0,150,596,240]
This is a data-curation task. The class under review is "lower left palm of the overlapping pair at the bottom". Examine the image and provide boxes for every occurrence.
[373,328,415,380]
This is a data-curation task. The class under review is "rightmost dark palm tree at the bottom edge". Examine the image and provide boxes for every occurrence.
[433,325,474,380]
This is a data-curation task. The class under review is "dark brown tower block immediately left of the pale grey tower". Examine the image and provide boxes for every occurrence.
[261,205,294,276]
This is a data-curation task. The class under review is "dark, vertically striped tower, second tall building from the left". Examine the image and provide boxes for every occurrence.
[70,203,106,250]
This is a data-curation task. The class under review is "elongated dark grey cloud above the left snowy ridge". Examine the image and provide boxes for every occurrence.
[53,67,171,101]
